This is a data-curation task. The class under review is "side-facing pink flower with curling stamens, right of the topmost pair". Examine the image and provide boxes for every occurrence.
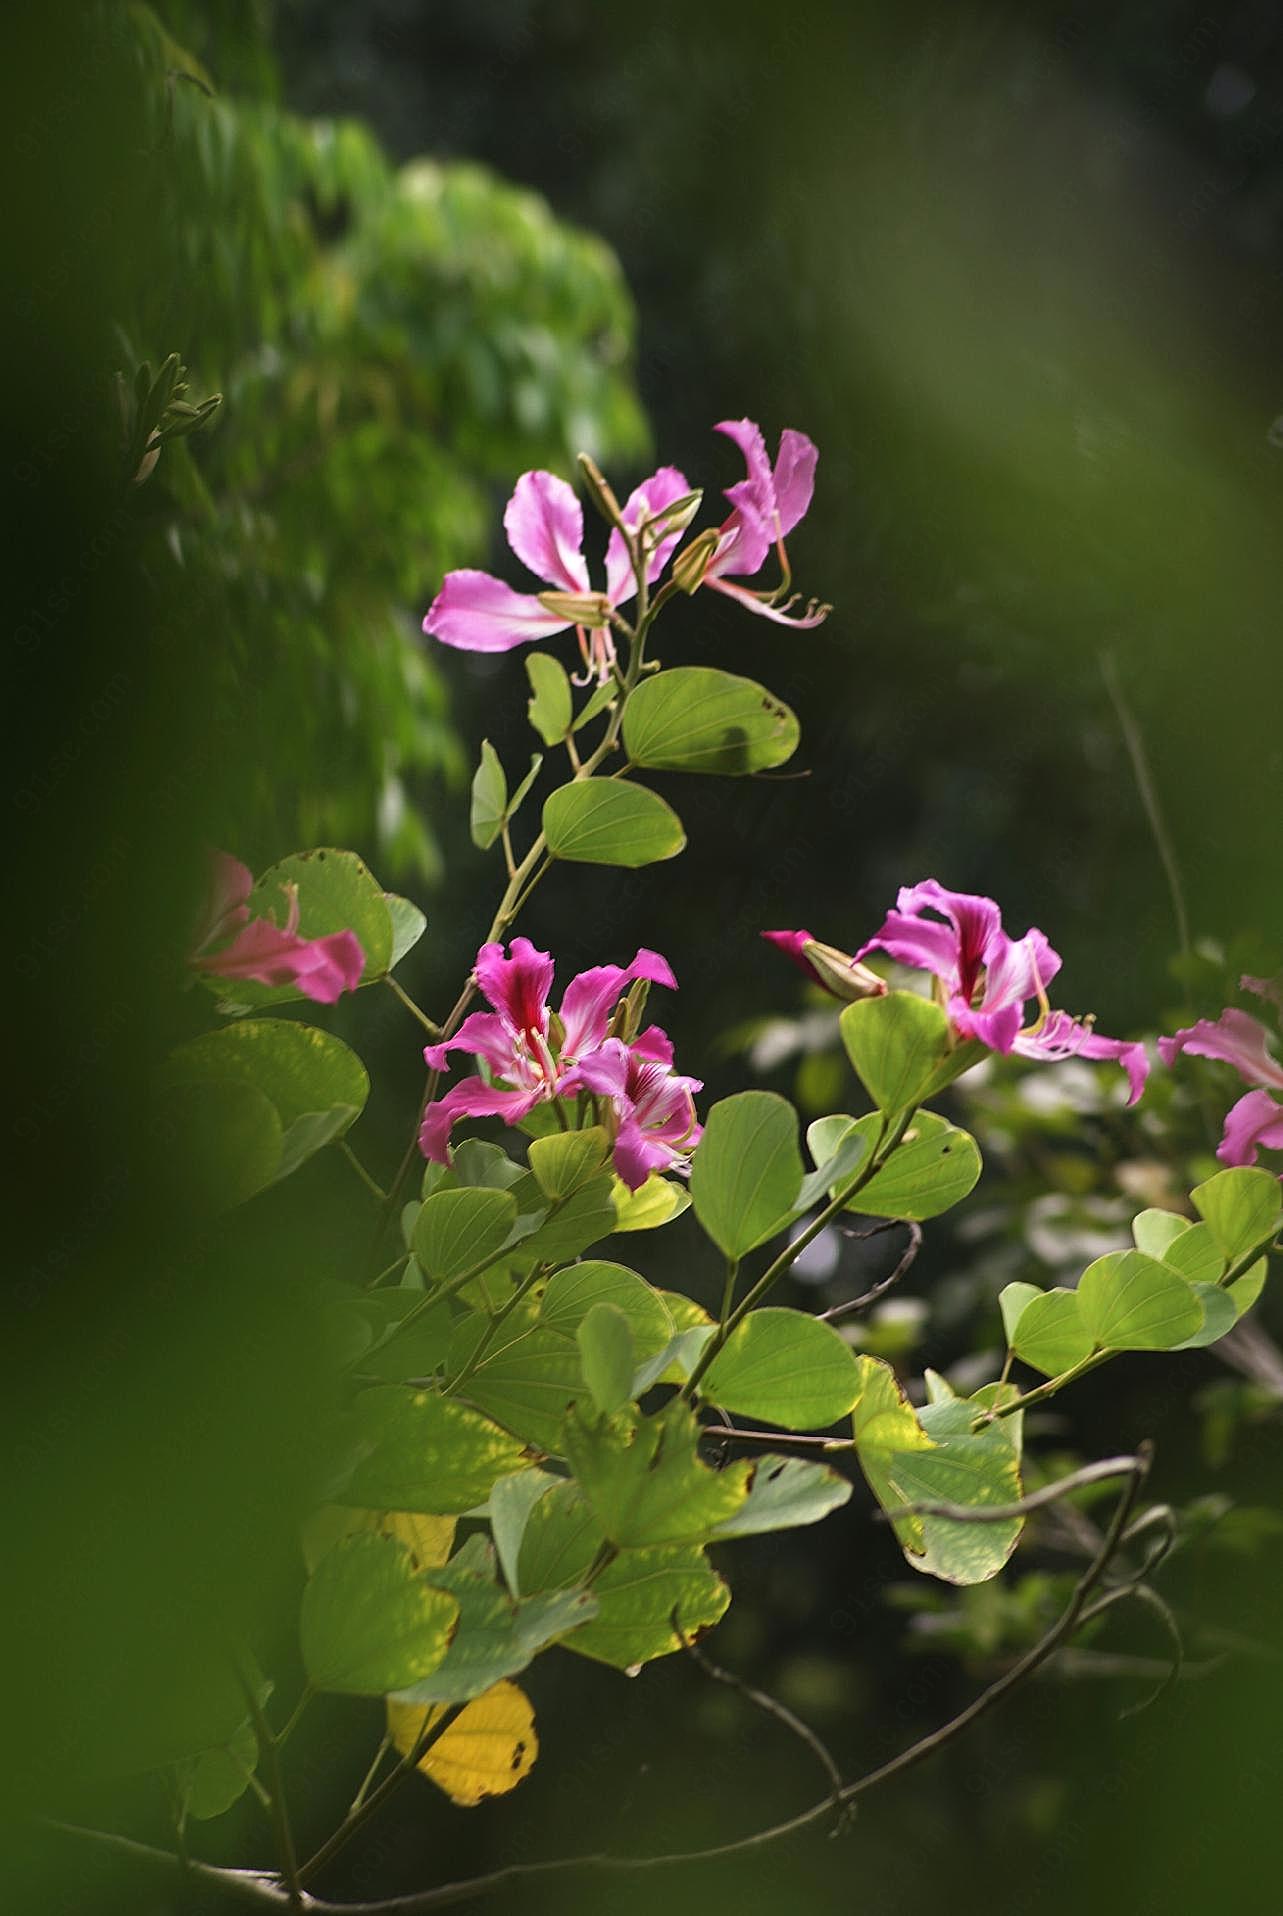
[699,420,831,627]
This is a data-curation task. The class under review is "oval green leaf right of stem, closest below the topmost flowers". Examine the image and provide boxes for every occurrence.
[624,665,799,778]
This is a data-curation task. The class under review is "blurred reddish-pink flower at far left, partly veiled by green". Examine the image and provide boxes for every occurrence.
[190,853,366,1004]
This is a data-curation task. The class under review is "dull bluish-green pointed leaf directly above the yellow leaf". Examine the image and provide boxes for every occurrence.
[394,1537,597,1703]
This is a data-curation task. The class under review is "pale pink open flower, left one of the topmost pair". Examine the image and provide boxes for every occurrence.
[423,466,689,678]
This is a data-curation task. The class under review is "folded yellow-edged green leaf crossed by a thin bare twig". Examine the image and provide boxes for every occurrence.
[852,1357,1021,1585]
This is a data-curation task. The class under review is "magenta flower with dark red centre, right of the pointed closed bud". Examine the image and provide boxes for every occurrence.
[856,878,1149,1104]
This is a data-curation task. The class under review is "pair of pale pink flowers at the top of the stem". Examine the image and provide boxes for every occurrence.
[423,420,827,680]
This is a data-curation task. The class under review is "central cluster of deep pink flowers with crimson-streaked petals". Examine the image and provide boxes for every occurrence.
[419,939,701,1190]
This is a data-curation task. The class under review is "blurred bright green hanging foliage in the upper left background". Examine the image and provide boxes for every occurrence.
[115,8,647,878]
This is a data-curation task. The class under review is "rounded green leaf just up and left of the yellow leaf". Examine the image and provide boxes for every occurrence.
[299,1531,460,1696]
